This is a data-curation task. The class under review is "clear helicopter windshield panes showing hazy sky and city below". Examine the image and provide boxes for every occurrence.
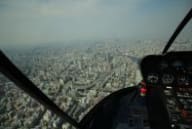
[0,0,192,129]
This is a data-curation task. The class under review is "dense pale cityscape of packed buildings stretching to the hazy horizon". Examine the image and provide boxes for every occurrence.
[0,40,192,129]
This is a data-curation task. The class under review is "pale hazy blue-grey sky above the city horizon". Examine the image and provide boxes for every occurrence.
[0,0,192,46]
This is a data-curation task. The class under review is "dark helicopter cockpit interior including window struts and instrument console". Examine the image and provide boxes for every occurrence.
[0,5,192,129]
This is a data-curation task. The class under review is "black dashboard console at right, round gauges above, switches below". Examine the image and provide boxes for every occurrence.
[140,52,192,129]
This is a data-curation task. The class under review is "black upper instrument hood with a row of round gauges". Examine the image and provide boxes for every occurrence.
[140,52,192,87]
